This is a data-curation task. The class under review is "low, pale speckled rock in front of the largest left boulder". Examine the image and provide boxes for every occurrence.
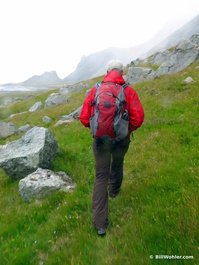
[19,168,76,201]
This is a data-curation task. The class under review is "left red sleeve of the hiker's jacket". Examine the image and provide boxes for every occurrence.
[79,88,94,128]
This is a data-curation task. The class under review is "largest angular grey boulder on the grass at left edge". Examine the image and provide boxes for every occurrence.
[0,127,59,179]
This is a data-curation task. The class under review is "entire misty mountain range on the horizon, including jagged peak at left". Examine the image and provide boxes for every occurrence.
[1,15,199,87]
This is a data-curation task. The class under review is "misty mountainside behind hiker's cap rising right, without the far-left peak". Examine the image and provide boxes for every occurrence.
[64,15,199,83]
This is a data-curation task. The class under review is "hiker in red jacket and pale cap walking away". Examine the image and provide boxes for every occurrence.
[80,59,144,235]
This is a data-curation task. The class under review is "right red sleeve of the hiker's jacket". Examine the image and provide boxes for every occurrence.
[127,87,144,131]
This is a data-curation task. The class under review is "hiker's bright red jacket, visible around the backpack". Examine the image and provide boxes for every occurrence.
[80,70,144,136]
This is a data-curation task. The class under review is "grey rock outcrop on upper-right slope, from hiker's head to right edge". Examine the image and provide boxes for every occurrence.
[125,34,199,84]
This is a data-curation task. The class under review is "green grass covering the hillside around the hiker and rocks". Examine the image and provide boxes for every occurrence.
[0,61,199,265]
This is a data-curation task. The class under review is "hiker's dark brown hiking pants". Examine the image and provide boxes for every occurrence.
[92,138,130,229]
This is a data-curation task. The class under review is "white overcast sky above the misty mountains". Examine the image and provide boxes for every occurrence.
[0,0,199,84]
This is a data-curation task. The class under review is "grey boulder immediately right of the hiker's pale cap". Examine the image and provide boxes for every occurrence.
[125,67,155,84]
